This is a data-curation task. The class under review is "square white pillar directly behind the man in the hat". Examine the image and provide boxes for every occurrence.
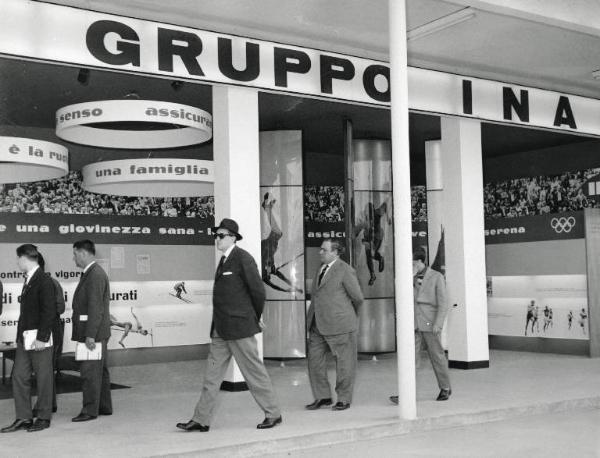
[213,86,262,388]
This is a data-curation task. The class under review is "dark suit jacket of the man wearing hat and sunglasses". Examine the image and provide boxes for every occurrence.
[211,246,265,340]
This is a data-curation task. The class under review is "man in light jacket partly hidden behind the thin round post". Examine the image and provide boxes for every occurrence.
[390,251,452,404]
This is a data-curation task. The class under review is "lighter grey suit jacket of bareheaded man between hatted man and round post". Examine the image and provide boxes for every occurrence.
[308,258,364,336]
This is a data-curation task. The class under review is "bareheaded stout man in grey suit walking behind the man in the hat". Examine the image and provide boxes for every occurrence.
[306,239,364,410]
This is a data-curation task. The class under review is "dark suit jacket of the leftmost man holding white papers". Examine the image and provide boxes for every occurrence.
[17,267,56,342]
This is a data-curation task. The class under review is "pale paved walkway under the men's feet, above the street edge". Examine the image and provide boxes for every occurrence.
[0,351,600,458]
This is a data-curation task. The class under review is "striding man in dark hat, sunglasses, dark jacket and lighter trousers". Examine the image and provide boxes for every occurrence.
[177,218,282,432]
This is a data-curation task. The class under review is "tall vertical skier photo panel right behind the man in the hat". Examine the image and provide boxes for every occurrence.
[260,130,306,358]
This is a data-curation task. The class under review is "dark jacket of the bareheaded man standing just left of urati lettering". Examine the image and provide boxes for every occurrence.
[71,263,110,342]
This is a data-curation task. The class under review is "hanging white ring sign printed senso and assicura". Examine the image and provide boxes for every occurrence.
[56,100,212,149]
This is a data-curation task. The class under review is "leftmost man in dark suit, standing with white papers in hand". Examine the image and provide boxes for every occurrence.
[0,244,56,433]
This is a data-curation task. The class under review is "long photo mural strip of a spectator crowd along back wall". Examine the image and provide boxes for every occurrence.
[0,168,600,223]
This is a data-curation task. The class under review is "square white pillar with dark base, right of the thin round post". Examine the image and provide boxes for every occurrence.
[442,116,489,369]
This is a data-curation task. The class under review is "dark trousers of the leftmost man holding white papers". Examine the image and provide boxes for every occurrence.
[12,342,54,420]
